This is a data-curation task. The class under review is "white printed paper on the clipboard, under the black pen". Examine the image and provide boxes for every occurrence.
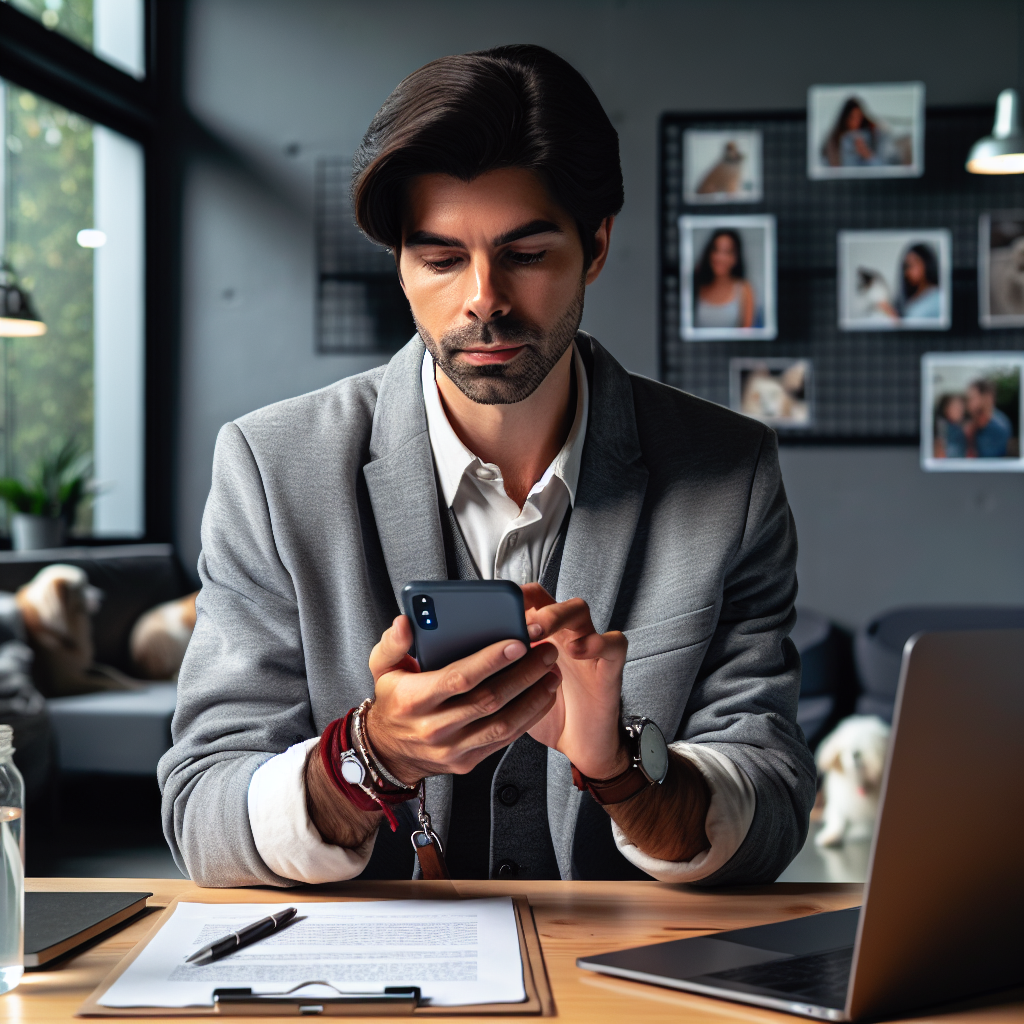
[99,897,526,1007]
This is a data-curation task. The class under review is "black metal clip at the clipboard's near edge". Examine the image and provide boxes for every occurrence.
[213,981,420,1017]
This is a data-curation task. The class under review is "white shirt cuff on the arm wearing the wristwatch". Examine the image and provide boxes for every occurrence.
[611,742,757,882]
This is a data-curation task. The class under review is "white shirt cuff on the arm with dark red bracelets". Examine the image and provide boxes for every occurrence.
[249,736,377,885]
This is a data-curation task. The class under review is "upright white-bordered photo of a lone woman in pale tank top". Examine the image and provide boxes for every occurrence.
[679,214,777,341]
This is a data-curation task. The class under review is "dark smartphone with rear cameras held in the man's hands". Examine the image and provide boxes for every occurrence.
[401,580,529,672]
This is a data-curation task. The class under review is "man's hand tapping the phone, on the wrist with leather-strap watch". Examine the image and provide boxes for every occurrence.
[522,583,629,779]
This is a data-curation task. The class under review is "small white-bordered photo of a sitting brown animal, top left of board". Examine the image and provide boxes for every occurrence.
[683,128,762,205]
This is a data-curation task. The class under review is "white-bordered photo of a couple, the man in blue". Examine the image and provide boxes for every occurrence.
[921,352,1024,473]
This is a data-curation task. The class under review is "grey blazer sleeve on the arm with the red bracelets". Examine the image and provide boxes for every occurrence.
[157,423,315,886]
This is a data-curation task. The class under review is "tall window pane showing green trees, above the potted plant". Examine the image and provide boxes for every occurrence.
[0,78,145,537]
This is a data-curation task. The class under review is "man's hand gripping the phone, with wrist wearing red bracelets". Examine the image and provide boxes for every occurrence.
[305,615,561,849]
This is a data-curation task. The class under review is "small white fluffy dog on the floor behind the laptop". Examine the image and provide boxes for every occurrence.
[814,715,891,846]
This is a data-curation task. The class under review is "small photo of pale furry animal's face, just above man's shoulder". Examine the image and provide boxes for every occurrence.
[729,358,813,430]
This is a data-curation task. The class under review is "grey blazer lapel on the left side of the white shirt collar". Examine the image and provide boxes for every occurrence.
[362,337,447,608]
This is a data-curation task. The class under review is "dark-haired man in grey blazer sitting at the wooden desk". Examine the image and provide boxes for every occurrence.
[160,46,814,886]
